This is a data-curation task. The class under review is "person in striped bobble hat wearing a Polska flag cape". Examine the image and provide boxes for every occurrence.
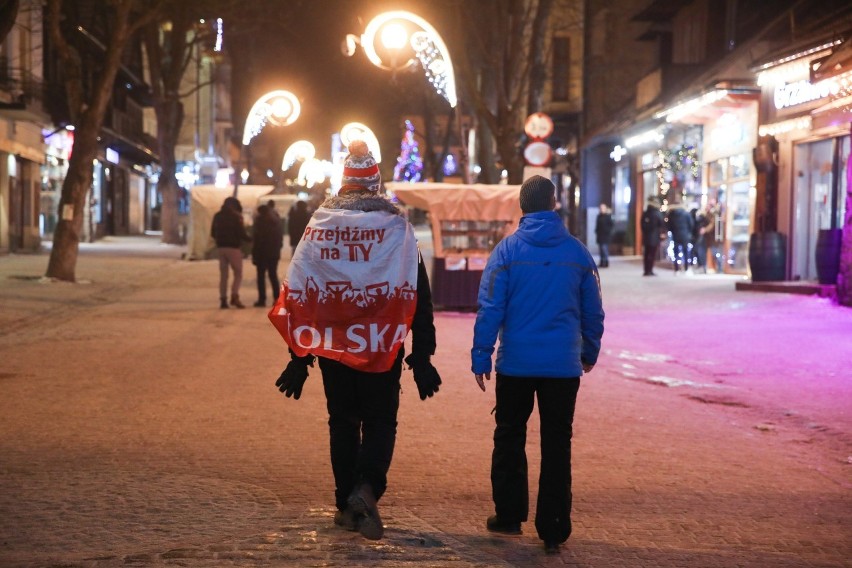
[269,140,441,540]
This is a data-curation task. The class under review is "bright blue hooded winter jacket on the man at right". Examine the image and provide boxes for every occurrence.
[471,211,604,378]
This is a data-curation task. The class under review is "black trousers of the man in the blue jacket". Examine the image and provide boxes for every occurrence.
[491,373,580,542]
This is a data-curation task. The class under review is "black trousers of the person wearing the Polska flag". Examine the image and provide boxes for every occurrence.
[319,351,402,511]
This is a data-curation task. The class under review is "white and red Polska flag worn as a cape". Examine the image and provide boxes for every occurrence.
[269,207,419,373]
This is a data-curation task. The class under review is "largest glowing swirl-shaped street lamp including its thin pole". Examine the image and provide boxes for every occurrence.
[343,10,468,183]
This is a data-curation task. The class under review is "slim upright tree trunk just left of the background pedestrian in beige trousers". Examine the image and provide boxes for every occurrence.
[155,98,183,245]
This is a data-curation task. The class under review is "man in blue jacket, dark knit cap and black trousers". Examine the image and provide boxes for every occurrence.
[471,176,604,553]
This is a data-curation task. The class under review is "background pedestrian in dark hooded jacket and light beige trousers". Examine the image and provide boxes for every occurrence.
[210,197,251,310]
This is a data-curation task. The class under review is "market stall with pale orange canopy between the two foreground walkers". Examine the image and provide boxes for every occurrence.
[386,183,522,309]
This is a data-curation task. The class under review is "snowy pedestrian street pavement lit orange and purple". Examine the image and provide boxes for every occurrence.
[0,239,852,568]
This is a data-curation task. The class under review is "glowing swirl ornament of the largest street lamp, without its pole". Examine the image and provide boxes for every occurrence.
[358,10,458,108]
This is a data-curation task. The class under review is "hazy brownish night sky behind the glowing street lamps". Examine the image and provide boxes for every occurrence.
[226,0,449,174]
